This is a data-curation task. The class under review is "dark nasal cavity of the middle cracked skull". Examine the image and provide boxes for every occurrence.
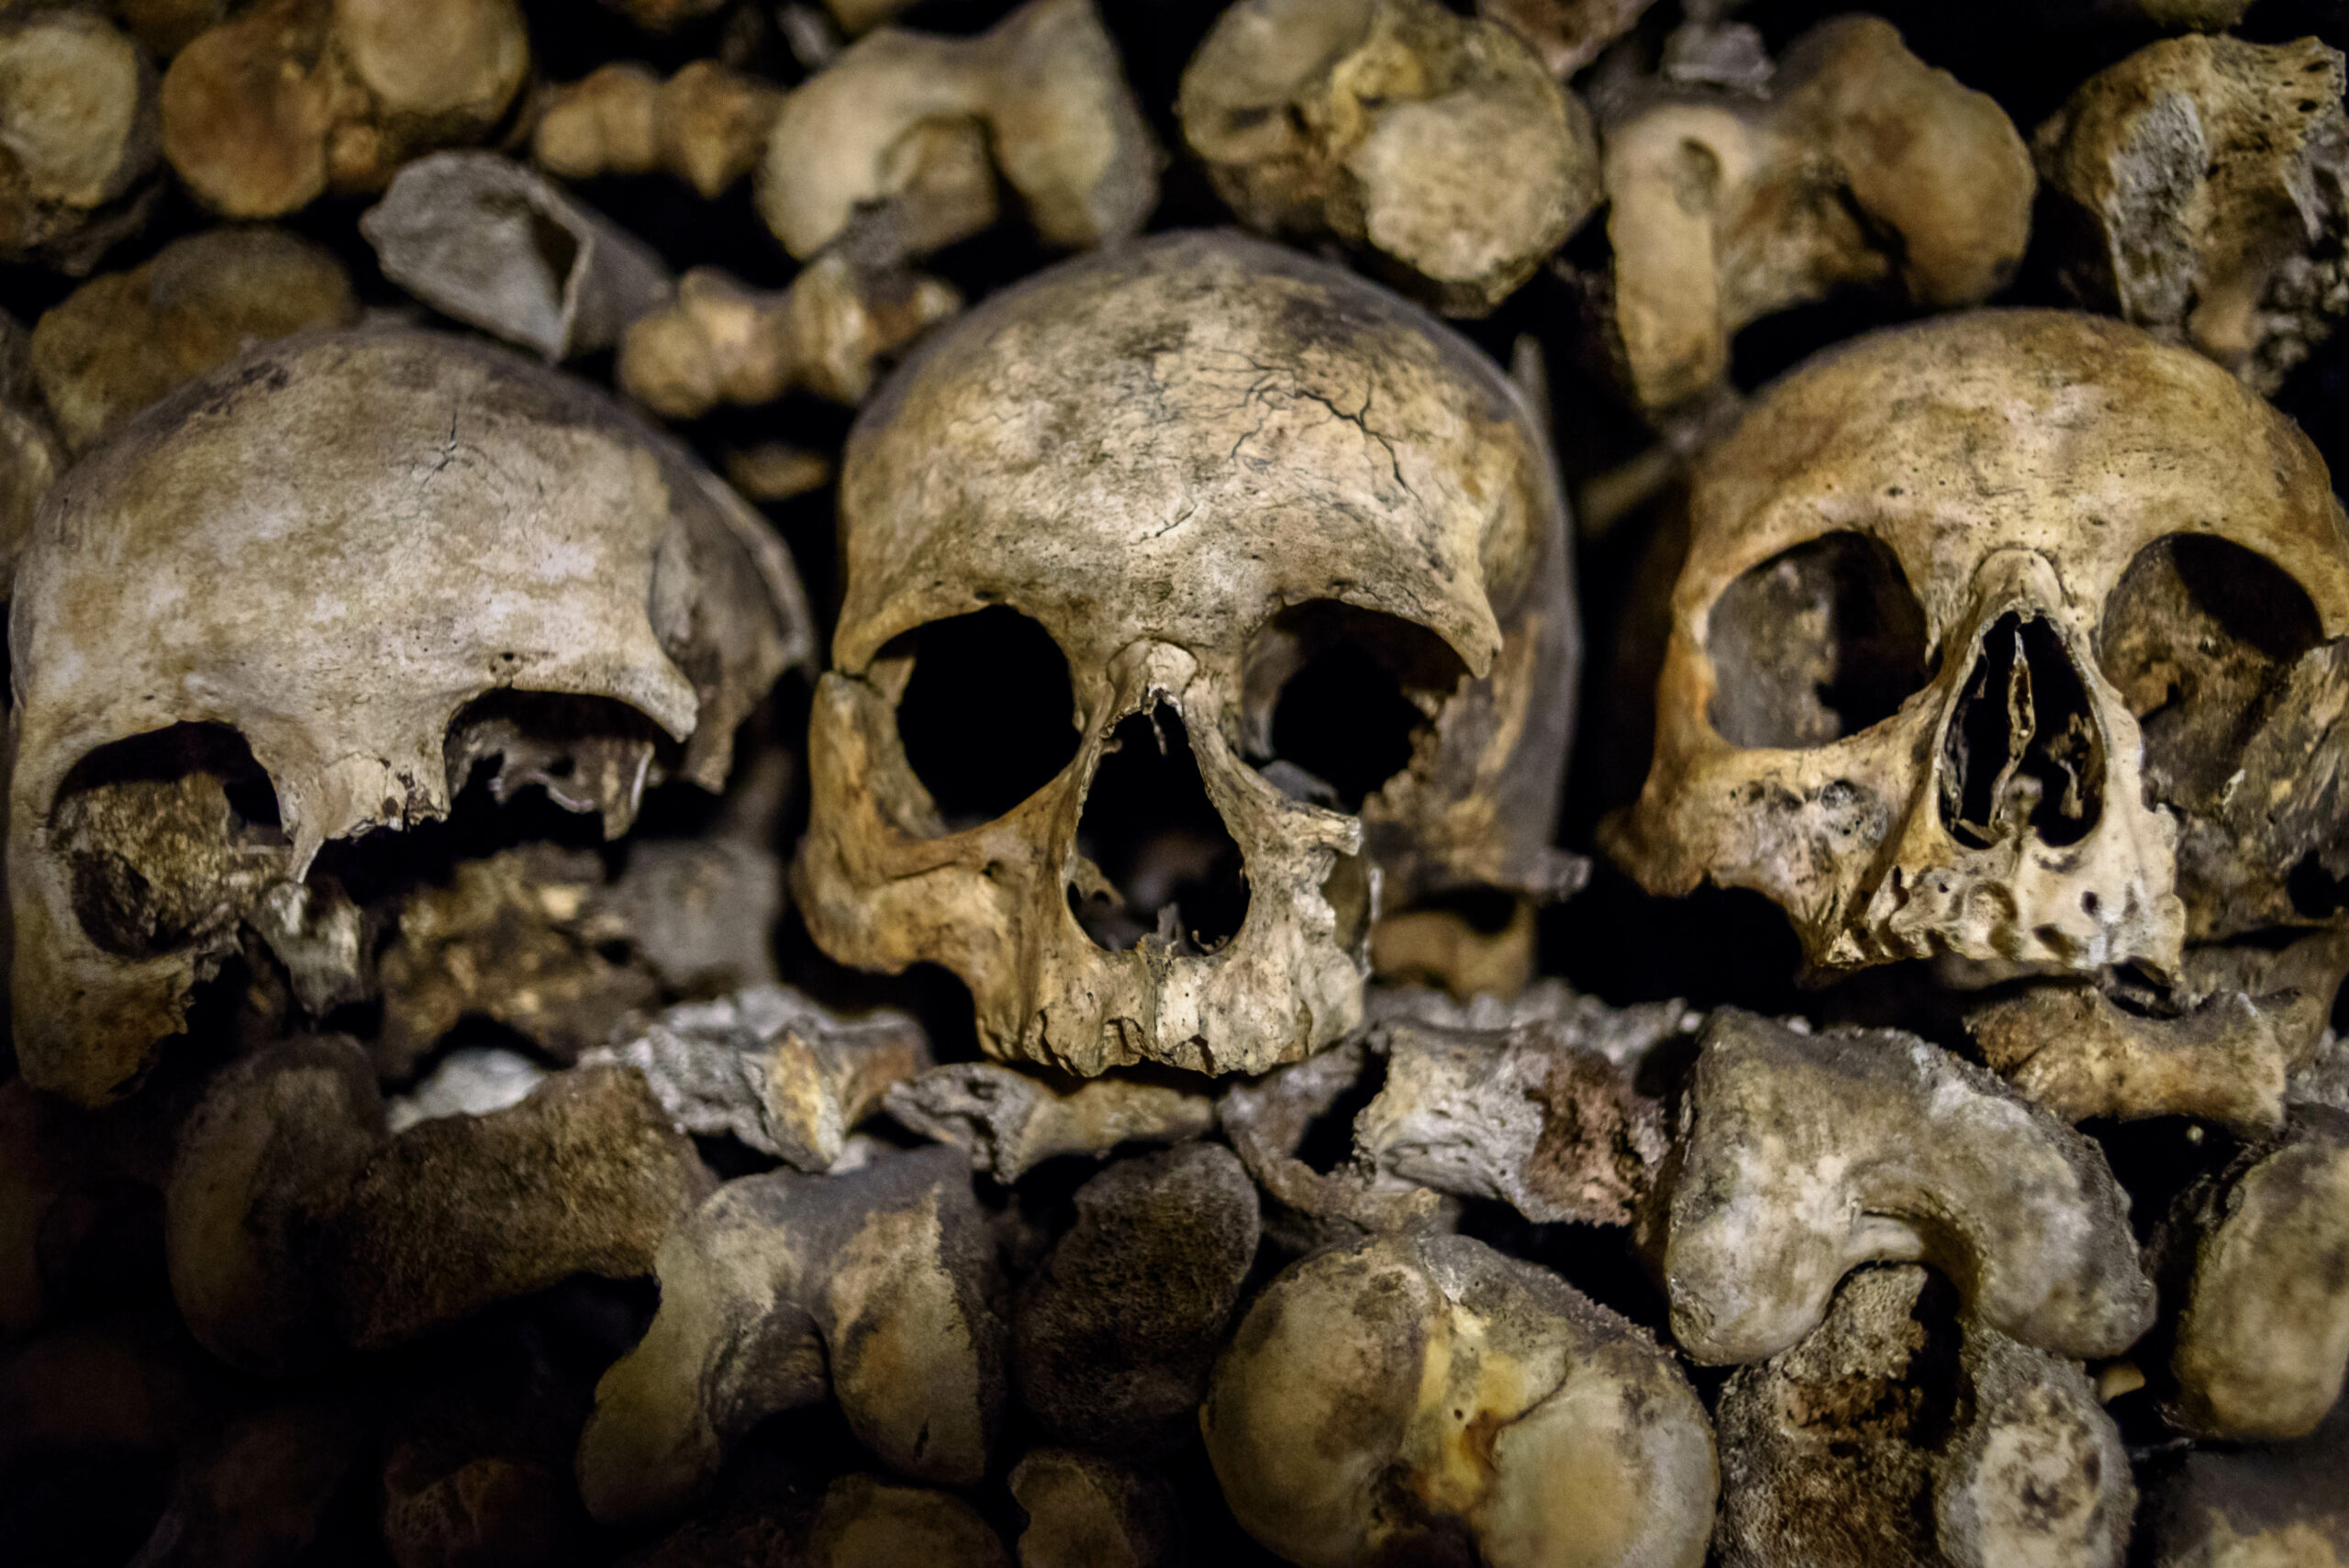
[1069,706,1247,953]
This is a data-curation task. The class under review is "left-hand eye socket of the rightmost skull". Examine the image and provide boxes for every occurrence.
[1706,530,1933,749]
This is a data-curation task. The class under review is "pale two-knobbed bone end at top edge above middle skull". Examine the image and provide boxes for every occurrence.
[759,0,1163,261]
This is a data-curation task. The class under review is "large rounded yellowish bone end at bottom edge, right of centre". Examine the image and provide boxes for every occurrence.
[1200,1237,1717,1568]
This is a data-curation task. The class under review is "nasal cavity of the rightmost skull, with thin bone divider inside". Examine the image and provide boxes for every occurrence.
[1941,610,2105,850]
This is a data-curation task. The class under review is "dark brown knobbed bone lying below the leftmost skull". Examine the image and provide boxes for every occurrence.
[164,1040,709,1373]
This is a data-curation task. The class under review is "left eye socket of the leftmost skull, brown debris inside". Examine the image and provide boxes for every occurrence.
[51,723,291,958]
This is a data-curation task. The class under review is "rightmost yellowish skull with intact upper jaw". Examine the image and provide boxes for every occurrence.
[1607,310,2349,972]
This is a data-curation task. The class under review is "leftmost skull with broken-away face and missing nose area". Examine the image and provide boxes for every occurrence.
[7,331,808,1103]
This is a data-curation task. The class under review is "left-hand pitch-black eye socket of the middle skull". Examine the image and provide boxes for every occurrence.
[881,606,1078,833]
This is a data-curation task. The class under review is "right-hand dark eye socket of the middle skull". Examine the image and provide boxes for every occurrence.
[1241,598,1468,812]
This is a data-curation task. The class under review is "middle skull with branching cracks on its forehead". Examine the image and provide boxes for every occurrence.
[794,232,1578,1075]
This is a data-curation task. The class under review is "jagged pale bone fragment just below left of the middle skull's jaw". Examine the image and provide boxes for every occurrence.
[580,986,930,1172]
